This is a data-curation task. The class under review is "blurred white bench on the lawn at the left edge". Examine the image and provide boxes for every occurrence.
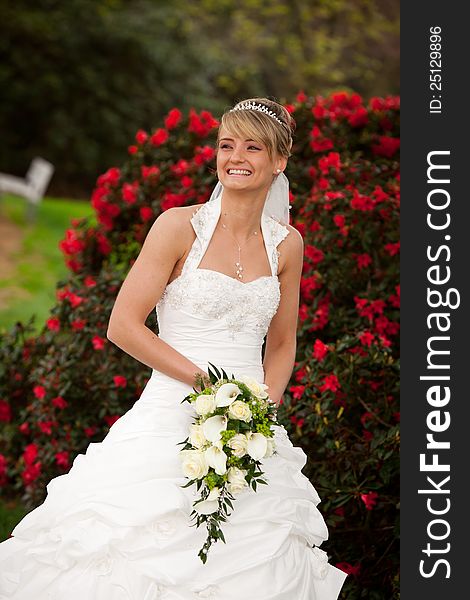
[0,157,54,222]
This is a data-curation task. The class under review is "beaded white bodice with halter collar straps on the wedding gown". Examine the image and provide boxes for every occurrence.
[156,196,289,344]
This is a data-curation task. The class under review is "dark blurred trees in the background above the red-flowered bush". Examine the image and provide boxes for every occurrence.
[0,0,399,198]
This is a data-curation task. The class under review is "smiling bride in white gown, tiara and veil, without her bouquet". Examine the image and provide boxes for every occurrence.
[0,98,346,600]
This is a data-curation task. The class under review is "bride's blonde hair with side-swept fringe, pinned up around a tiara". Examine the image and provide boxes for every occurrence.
[217,98,295,159]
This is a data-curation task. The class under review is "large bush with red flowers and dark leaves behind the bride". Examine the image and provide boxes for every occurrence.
[0,92,400,600]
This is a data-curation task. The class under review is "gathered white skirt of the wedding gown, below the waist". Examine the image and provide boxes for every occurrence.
[0,371,346,600]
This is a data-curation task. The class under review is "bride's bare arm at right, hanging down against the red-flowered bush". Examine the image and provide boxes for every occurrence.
[263,225,304,405]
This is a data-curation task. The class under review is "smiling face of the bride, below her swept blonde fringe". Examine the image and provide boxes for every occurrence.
[217,126,286,190]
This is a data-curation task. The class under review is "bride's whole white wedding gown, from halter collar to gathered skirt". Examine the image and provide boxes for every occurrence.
[0,196,346,600]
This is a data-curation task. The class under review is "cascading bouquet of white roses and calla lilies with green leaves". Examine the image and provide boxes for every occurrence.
[179,363,278,563]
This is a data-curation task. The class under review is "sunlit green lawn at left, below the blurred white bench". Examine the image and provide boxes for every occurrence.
[0,195,95,333]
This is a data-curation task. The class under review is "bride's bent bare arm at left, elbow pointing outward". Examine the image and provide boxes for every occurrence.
[106,208,208,386]
